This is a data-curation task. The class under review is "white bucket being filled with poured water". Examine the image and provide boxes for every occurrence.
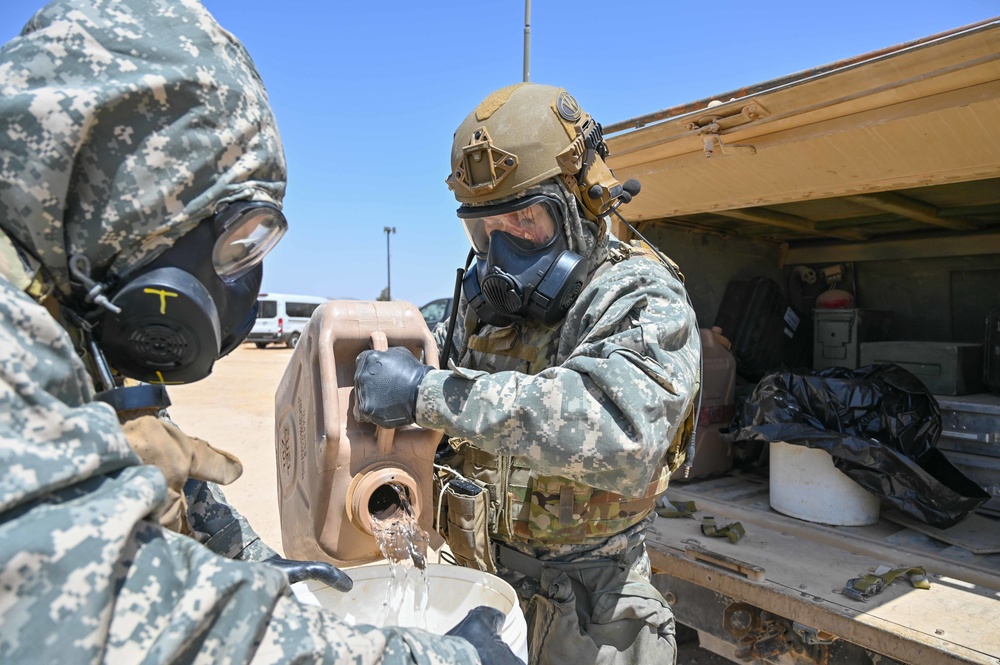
[292,563,528,662]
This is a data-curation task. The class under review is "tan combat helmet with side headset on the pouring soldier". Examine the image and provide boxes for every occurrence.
[447,83,624,222]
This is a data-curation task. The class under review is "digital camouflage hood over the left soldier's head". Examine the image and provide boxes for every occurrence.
[0,0,285,292]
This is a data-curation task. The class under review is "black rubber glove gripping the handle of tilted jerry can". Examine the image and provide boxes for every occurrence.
[354,346,431,428]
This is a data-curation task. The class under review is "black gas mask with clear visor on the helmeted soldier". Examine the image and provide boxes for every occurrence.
[458,194,587,326]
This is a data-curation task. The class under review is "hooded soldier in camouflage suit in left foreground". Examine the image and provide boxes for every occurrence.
[0,0,509,664]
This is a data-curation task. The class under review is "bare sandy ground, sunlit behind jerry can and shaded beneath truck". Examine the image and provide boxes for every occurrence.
[170,344,730,665]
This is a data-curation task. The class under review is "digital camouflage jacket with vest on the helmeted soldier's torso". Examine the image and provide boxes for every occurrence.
[416,184,701,558]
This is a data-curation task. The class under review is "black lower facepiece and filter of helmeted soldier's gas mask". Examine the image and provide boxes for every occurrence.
[462,224,587,326]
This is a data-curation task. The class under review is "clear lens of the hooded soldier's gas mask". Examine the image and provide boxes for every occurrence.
[212,201,288,281]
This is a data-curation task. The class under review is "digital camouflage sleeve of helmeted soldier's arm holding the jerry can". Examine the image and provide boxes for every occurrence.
[417,259,701,496]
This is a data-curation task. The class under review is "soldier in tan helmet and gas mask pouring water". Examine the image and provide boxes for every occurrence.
[355,84,701,664]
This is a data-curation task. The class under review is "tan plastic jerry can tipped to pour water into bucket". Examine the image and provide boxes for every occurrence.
[275,300,442,567]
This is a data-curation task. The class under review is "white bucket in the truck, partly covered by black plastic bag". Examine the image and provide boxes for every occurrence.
[770,441,879,526]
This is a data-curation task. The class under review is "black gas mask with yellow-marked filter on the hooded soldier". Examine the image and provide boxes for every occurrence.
[94,201,288,384]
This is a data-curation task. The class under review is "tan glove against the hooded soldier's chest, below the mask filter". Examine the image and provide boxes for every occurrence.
[122,415,243,534]
